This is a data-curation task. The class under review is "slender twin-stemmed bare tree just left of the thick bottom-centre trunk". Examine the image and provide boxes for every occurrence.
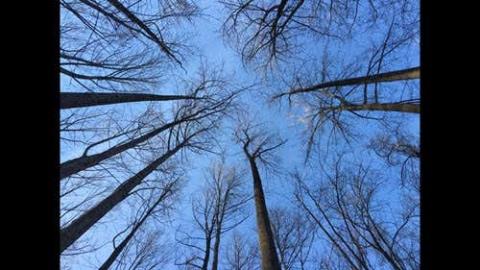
[177,161,250,270]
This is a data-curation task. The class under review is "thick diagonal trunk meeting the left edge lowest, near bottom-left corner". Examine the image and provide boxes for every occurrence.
[60,139,188,252]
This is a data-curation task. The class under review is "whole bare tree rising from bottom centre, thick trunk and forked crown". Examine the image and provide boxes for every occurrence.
[236,123,285,270]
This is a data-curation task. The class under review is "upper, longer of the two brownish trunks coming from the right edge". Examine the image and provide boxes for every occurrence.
[275,67,420,98]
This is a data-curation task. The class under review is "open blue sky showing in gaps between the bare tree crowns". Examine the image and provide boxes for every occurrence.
[60,0,419,270]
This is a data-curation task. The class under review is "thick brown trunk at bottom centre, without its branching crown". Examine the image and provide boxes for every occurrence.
[248,157,281,270]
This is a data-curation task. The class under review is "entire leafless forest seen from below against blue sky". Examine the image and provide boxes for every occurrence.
[57,0,420,270]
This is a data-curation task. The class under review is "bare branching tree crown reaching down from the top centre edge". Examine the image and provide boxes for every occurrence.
[221,0,350,65]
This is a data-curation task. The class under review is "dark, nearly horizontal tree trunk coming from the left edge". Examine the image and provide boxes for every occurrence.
[60,92,195,109]
